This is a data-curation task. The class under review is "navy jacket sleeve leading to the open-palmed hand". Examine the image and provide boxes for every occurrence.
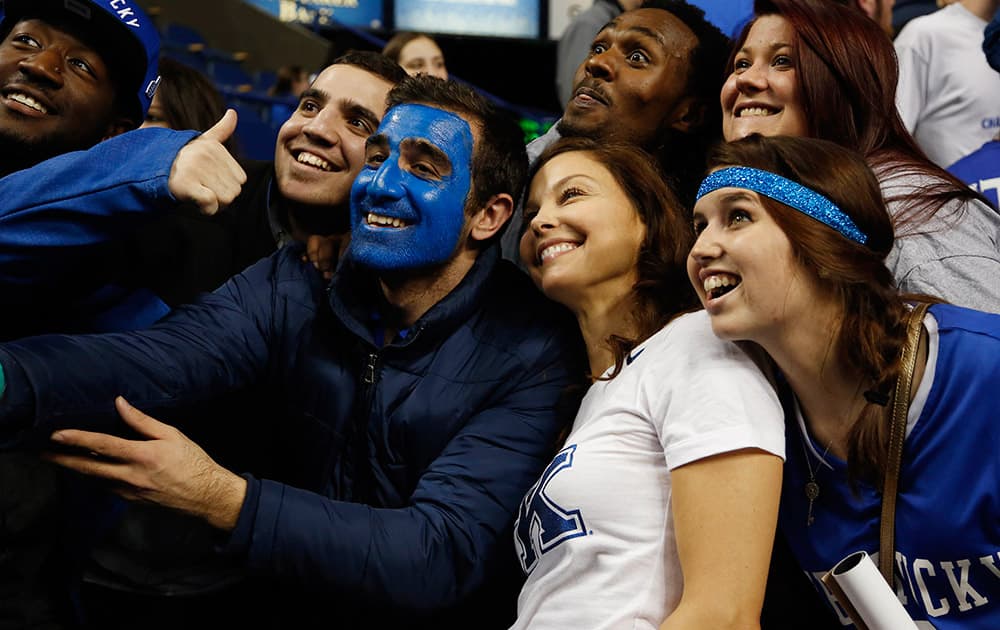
[223,339,570,611]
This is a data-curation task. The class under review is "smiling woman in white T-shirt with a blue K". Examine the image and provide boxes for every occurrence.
[514,139,784,630]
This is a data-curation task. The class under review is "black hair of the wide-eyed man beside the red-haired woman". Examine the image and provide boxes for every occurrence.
[639,0,731,206]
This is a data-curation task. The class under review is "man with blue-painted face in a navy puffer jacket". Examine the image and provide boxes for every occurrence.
[0,76,584,628]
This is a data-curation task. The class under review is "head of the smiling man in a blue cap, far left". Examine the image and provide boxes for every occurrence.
[0,0,160,175]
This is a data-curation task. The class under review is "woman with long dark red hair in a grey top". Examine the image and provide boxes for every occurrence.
[721,0,1000,312]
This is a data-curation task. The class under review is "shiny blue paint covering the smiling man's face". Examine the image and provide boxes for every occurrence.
[350,104,473,271]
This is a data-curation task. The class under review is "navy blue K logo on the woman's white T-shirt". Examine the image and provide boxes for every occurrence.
[514,444,587,574]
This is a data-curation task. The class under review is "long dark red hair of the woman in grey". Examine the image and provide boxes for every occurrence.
[729,0,989,227]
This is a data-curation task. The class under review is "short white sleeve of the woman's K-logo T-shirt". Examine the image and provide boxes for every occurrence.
[642,311,785,470]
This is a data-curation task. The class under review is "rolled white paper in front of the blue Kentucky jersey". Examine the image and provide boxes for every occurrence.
[830,551,917,630]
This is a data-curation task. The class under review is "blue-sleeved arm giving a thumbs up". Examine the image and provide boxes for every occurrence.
[0,112,246,304]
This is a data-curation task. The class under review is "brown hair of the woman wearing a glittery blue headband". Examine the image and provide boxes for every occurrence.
[710,135,939,483]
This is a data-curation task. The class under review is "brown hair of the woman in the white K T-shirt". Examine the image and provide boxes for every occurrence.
[529,137,698,380]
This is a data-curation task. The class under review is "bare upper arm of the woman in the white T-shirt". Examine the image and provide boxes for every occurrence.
[660,449,782,630]
